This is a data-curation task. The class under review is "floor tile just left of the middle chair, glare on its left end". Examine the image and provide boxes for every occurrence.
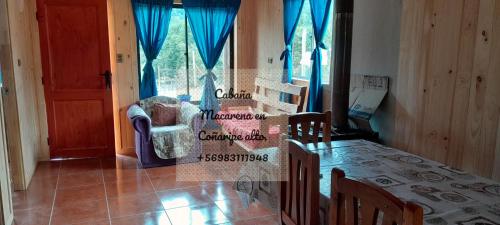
[215,199,273,220]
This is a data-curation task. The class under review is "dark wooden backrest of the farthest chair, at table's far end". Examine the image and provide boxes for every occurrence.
[288,111,332,144]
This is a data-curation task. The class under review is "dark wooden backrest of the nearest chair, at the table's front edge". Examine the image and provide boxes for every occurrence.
[329,169,423,225]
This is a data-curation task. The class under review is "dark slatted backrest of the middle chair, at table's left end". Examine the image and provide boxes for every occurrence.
[280,140,319,225]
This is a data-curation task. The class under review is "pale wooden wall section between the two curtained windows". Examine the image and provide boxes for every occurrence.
[235,0,284,92]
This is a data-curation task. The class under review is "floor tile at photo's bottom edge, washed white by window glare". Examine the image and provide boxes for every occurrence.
[167,204,230,225]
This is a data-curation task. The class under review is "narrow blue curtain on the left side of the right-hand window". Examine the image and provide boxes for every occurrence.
[280,0,304,102]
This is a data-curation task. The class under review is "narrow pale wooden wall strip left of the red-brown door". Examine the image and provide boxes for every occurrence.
[2,0,42,190]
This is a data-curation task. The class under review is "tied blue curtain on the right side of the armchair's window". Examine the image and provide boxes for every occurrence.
[182,0,241,125]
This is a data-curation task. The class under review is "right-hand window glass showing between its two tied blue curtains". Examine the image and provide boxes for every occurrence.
[293,0,334,83]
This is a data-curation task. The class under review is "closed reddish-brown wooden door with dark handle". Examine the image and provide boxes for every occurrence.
[37,0,115,158]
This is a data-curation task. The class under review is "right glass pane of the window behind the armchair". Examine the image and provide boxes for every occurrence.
[188,23,229,101]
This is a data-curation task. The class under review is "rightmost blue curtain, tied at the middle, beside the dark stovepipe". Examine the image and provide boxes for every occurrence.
[307,0,332,112]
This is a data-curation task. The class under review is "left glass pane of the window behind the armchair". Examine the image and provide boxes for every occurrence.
[140,8,187,97]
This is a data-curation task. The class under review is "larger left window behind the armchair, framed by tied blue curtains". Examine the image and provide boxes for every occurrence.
[139,5,229,101]
